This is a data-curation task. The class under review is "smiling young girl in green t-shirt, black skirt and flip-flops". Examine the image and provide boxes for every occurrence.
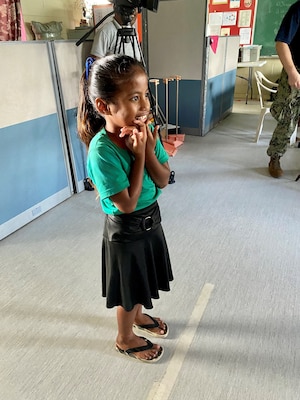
[78,55,173,362]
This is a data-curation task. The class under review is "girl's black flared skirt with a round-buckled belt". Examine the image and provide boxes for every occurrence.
[102,202,173,311]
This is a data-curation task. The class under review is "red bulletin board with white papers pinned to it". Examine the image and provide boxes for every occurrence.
[208,0,258,46]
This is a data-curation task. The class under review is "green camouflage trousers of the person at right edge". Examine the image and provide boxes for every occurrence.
[267,69,300,157]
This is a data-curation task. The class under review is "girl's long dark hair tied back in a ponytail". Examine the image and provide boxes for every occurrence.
[77,55,146,147]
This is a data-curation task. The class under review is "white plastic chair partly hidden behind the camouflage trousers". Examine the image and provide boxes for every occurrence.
[254,71,297,145]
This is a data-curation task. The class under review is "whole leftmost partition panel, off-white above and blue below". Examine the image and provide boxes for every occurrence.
[0,41,71,239]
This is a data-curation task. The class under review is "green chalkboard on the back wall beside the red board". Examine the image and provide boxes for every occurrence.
[253,0,296,56]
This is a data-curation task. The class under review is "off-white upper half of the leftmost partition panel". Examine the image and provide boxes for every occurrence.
[0,42,57,129]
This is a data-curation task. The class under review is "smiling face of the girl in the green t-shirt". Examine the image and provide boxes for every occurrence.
[105,70,150,134]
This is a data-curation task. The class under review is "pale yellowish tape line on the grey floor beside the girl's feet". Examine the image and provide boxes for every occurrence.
[147,283,214,400]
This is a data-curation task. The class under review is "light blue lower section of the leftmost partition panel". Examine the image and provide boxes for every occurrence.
[0,114,68,224]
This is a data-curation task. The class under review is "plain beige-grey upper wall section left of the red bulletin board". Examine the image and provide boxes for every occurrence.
[148,0,207,80]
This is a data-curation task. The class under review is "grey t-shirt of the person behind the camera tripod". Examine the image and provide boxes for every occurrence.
[91,19,141,61]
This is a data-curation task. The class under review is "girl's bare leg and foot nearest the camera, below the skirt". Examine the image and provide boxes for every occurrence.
[116,304,161,360]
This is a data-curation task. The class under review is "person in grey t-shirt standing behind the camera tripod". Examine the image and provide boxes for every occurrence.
[91,0,141,61]
